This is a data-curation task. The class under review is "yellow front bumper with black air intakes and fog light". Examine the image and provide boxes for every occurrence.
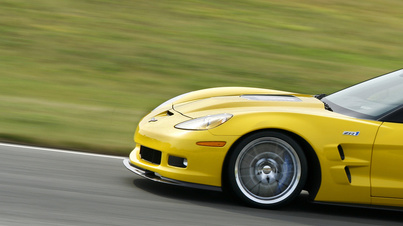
[128,107,238,187]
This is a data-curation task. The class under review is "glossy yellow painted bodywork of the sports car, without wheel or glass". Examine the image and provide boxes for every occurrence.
[129,87,403,206]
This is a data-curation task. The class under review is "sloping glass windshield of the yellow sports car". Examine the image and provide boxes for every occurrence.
[322,69,403,119]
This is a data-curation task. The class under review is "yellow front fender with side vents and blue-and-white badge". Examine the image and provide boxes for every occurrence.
[210,112,381,204]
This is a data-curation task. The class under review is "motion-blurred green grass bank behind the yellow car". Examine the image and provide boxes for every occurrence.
[0,0,403,155]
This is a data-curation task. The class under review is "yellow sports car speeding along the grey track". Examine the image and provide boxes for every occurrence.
[124,70,403,208]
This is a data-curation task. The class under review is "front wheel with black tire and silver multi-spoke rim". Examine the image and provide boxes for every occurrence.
[223,131,308,209]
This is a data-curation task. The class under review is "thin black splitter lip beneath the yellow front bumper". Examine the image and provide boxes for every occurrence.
[123,159,221,191]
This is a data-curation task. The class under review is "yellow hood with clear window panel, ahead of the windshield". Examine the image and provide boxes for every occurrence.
[172,87,324,118]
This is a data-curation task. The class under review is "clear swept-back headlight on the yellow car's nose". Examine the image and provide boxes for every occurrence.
[175,113,232,130]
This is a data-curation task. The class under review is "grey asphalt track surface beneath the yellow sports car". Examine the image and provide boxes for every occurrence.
[0,144,403,226]
